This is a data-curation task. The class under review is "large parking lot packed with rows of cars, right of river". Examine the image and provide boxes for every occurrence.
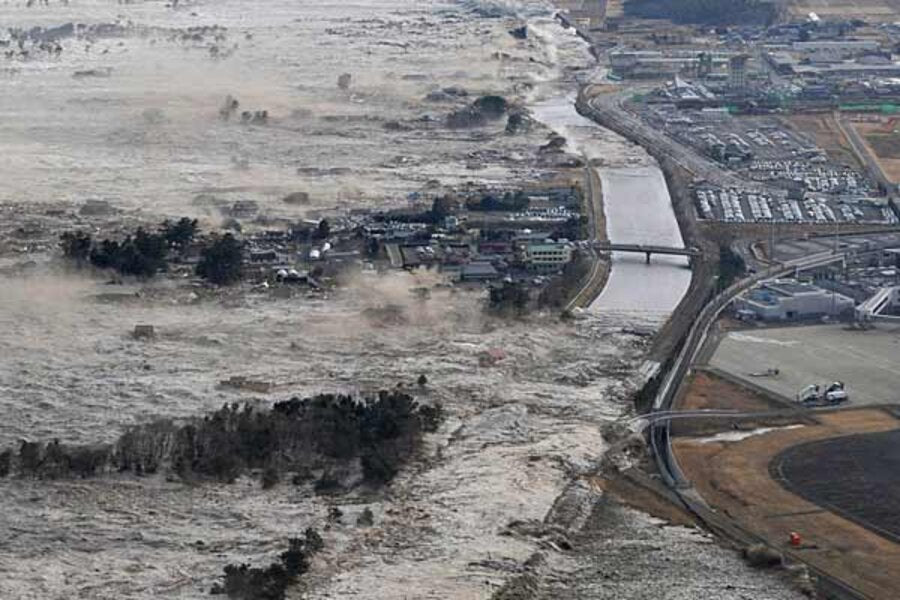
[637,103,900,224]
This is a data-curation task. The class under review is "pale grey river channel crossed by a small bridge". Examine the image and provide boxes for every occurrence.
[529,8,691,325]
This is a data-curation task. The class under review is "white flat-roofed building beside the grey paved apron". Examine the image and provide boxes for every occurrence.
[736,279,855,321]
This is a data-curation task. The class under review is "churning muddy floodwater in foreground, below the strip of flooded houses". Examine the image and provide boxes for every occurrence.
[0,274,790,599]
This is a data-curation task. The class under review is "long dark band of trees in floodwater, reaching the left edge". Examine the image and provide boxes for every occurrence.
[0,391,443,487]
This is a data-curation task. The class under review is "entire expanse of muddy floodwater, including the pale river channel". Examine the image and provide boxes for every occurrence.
[0,0,796,600]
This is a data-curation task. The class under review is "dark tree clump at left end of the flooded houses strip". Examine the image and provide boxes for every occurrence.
[60,217,243,285]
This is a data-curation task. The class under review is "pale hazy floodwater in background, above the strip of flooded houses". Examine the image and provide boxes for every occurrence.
[0,0,556,218]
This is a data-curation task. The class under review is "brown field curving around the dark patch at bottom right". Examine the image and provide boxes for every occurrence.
[674,409,900,600]
